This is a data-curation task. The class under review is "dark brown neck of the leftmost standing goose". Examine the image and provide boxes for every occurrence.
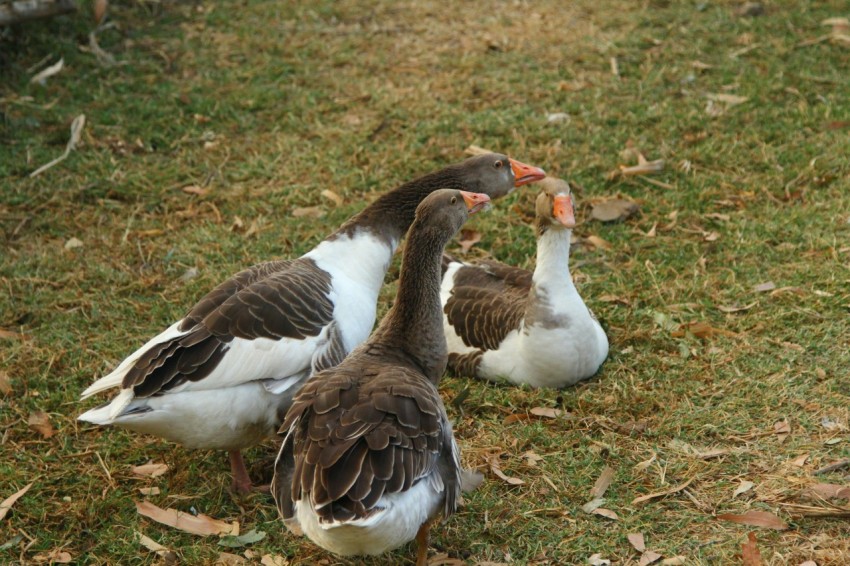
[331,166,467,249]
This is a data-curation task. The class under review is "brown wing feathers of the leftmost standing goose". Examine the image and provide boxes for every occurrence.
[122,258,334,397]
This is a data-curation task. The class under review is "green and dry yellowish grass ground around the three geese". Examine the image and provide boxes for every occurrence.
[0,0,850,565]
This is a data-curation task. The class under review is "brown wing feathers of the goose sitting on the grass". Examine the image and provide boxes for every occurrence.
[443,261,532,350]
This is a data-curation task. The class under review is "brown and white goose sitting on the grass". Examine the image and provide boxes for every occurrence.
[441,177,608,388]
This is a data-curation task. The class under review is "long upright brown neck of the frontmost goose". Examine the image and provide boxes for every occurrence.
[369,220,448,383]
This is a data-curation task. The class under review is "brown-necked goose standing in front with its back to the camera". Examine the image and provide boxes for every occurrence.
[272,190,489,565]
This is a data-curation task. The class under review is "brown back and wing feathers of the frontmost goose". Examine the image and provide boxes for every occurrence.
[273,364,459,521]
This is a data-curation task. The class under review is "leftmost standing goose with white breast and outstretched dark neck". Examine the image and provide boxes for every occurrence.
[79,154,544,493]
